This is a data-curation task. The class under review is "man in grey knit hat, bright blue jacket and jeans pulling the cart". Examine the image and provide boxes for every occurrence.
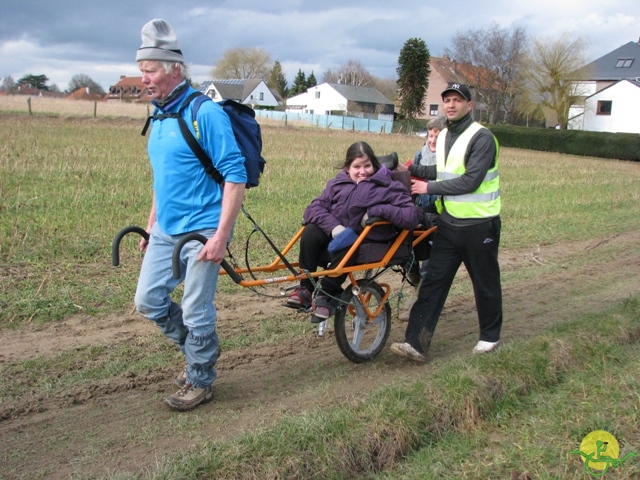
[135,19,247,410]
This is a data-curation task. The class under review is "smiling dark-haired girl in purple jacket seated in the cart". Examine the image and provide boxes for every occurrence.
[286,142,420,323]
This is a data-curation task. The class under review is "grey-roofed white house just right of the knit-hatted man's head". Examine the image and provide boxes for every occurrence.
[200,78,279,108]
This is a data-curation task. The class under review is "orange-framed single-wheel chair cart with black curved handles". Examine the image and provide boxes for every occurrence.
[112,152,437,363]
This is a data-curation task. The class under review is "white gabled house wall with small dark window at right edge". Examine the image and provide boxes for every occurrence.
[569,80,640,134]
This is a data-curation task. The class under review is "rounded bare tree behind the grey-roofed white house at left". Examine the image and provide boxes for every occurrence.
[211,47,271,79]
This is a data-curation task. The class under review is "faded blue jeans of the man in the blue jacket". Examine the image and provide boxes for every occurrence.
[135,223,220,388]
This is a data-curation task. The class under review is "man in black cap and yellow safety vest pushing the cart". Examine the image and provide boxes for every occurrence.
[391,83,502,362]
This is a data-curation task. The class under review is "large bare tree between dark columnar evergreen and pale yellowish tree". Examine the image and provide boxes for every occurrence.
[446,23,528,123]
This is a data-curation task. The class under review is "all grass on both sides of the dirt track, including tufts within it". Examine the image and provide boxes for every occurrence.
[0,109,640,479]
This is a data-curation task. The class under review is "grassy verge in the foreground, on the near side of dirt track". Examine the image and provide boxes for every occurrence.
[100,298,640,479]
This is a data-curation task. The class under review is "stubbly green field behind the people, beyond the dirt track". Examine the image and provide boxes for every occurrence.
[0,115,640,328]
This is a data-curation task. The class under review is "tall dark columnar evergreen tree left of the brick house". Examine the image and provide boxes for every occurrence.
[396,38,431,119]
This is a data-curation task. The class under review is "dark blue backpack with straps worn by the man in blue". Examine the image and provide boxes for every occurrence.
[142,92,266,188]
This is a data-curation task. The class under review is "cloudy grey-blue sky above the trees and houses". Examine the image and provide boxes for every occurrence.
[0,0,640,90]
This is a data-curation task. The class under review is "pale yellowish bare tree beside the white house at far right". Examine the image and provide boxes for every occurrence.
[523,32,586,129]
